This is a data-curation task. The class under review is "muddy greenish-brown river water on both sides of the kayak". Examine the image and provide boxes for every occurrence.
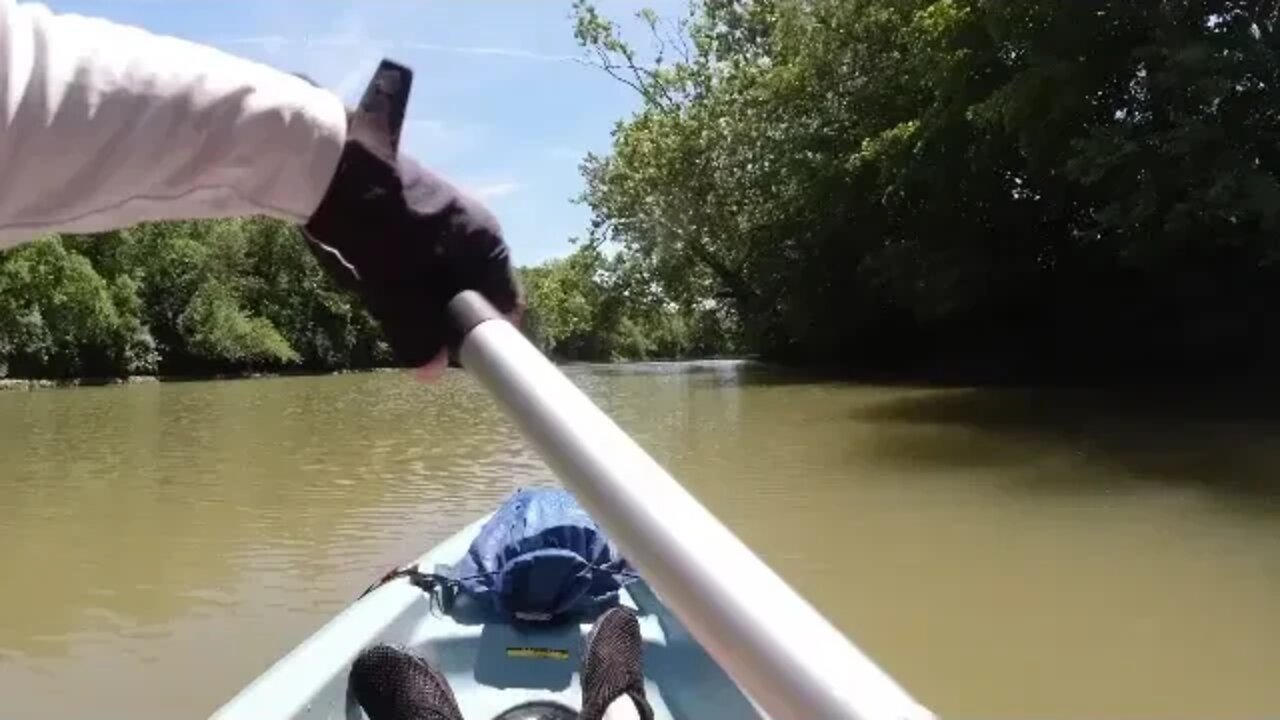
[0,363,1280,719]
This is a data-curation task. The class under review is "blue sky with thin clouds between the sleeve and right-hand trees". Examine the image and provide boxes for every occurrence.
[46,0,686,264]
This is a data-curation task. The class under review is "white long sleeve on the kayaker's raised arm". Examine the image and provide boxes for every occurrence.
[0,0,347,247]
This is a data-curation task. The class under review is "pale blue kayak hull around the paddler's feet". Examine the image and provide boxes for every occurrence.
[212,512,764,720]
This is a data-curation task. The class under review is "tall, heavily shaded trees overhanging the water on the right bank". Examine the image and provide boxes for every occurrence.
[576,0,1280,373]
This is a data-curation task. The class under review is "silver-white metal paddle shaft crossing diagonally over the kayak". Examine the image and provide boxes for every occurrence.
[449,291,933,720]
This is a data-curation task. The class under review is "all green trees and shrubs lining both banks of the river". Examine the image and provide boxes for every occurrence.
[0,0,1280,384]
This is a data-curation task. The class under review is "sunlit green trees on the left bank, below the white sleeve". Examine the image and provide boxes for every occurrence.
[0,218,390,378]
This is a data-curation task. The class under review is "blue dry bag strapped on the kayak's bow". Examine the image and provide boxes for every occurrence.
[444,488,634,623]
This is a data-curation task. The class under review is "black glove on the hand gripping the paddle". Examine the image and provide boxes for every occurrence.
[303,60,522,366]
